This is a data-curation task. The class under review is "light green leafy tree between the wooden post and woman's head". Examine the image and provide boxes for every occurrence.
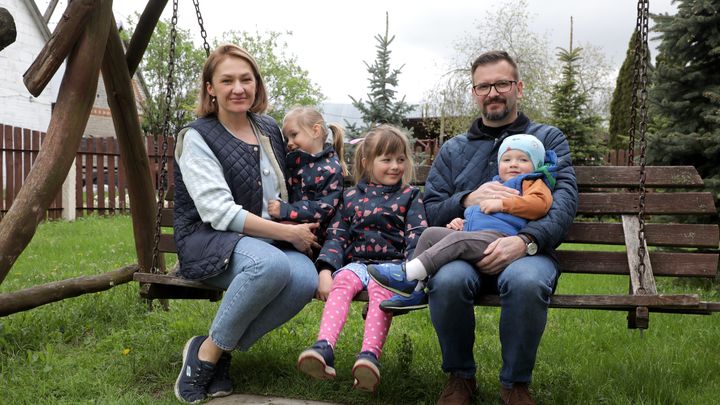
[128,20,205,136]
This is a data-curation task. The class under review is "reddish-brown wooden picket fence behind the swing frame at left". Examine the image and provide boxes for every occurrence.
[0,125,175,219]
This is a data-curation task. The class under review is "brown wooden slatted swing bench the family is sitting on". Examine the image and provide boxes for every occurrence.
[134,166,720,329]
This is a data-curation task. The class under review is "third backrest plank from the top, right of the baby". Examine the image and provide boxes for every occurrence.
[563,222,720,249]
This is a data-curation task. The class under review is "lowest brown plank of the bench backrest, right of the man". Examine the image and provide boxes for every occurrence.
[556,250,718,278]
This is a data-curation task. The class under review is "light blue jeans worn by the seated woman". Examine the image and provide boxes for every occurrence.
[205,236,318,351]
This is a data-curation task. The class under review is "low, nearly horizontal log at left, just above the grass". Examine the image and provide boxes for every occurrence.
[0,265,138,316]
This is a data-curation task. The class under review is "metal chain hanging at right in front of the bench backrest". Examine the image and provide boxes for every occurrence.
[633,0,650,293]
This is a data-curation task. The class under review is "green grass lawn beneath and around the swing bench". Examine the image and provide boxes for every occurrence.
[0,213,720,404]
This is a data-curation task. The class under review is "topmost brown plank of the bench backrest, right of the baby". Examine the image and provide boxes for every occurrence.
[575,166,704,188]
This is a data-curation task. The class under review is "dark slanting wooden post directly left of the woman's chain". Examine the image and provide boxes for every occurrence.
[102,18,165,271]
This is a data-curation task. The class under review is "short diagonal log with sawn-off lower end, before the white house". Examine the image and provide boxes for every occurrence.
[23,0,97,97]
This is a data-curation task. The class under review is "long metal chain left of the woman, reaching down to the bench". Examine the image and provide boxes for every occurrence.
[151,0,178,273]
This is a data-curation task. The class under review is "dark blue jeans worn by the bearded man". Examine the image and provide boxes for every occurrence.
[428,255,558,388]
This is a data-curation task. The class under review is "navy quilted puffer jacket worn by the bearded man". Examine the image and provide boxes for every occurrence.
[424,113,578,252]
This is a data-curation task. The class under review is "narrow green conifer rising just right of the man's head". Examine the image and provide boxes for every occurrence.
[550,48,605,165]
